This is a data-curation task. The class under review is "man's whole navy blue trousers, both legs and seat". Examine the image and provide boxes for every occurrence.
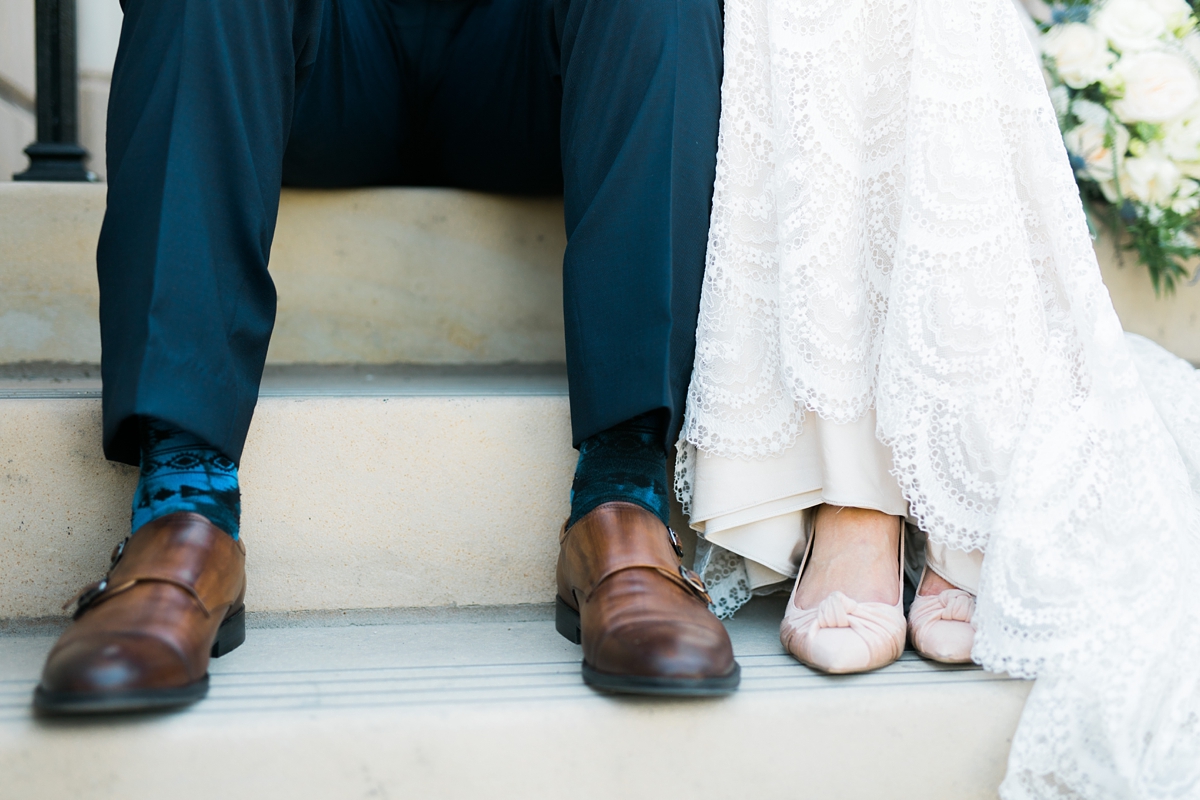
[97,0,720,463]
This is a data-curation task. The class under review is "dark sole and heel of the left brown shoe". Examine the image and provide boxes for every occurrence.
[34,606,246,716]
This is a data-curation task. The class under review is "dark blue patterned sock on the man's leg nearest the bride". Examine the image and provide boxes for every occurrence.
[566,410,671,528]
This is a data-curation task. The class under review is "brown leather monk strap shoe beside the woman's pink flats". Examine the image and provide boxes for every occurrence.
[557,503,740,697]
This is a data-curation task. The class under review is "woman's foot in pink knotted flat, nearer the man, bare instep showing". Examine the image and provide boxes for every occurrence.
[779,506,905,673]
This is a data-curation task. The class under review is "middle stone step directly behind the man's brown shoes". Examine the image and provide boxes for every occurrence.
[0,366,575,619]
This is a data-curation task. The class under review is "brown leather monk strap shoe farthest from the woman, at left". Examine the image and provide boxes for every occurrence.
[34,513,246,714]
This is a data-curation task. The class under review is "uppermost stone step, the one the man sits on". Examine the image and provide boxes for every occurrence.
[0,184,566,363]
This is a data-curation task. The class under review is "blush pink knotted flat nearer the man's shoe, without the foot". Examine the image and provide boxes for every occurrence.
[779,521,906,674]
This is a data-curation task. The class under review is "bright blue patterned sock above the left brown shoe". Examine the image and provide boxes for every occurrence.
[131,419,241,539]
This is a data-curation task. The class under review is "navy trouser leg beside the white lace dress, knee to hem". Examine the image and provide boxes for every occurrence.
[558,0,721,447]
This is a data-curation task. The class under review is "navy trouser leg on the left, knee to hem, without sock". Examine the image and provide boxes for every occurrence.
[96,0,323,464]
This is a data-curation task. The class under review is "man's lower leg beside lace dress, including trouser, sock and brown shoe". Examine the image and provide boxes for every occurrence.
[556,0,739,694]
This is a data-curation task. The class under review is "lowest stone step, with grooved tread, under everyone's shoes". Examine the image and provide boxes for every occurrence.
[0,597,1030,800]
